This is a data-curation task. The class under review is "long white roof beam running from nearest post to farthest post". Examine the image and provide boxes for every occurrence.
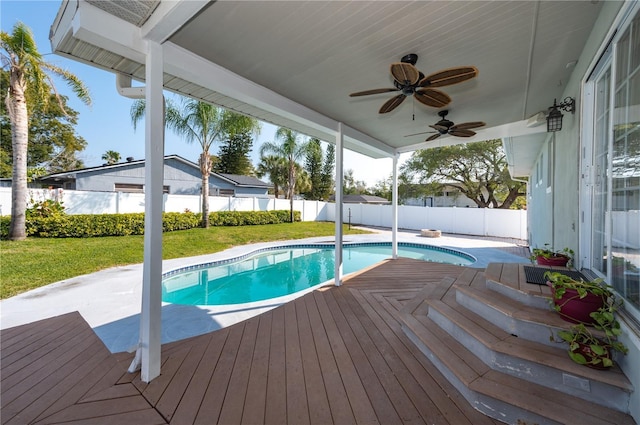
[164,42,394,156]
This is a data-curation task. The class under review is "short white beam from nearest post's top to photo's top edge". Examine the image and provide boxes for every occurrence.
[140,0,209,43]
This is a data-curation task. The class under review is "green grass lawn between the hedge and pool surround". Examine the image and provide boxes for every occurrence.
[0,222,367,299]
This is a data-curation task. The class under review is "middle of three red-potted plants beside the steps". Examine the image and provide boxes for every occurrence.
[544,271,614,324]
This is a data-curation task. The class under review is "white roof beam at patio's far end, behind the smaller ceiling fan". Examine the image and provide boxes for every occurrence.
[398,120,547,153]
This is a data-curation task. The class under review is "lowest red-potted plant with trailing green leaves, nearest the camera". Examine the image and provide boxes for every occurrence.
[558,298,629,369]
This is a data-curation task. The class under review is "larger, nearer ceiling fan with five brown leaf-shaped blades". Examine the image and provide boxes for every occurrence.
[349,53,478,114]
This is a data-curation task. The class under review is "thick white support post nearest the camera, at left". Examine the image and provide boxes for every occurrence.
[139,41,164,382]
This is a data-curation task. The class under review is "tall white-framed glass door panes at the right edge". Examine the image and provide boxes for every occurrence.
[584,4,640,319]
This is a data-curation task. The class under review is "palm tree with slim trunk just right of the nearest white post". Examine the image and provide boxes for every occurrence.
[131,98,260,228]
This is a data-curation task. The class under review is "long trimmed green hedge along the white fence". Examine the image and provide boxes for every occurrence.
[0,211,300,239]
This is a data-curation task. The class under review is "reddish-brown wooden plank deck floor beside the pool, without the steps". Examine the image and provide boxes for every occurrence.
[0,259,504,425]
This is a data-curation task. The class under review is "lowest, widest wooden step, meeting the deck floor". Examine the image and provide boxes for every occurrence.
[401,301,635,425]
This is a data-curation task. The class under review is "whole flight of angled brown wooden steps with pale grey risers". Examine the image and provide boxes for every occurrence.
[400,265,634,424]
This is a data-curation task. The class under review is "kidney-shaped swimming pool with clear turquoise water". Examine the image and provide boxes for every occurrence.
[162,242,475,305]
